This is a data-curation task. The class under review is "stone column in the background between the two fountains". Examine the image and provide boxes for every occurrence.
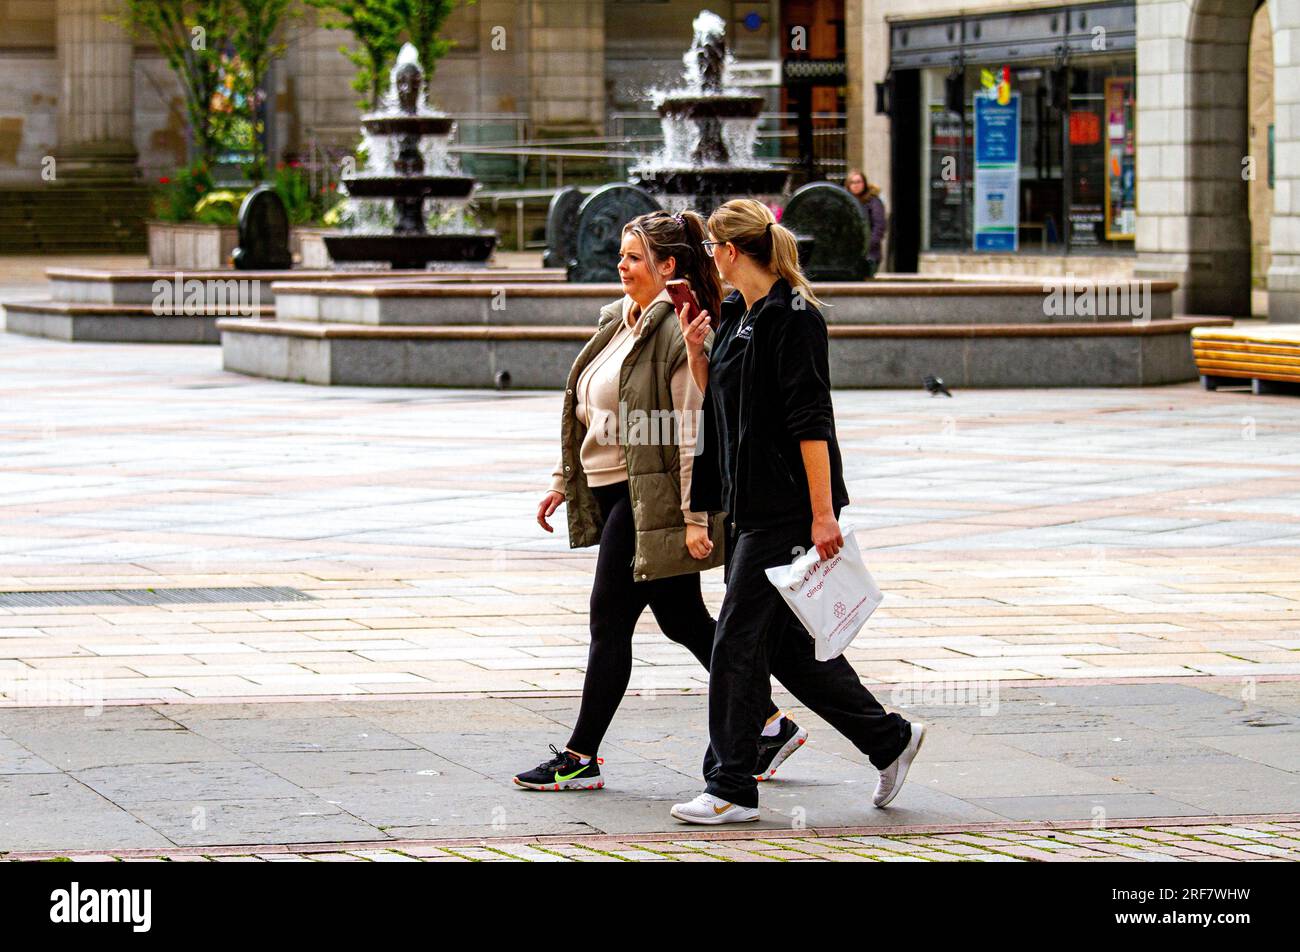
[528,0,606,134]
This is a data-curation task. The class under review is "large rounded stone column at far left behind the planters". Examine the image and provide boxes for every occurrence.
[56,0,135,179]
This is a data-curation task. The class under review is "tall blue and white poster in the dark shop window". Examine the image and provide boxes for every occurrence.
[975,92,1021,251]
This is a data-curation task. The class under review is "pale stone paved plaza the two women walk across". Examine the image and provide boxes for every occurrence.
[0,271,1300,860]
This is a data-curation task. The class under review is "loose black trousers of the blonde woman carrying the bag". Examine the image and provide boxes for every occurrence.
[705,522,911,806]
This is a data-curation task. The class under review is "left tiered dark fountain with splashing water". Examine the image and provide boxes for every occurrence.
[325,43,497,269]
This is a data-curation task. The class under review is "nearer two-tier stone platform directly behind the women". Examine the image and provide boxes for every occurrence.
[217,276,1231,389]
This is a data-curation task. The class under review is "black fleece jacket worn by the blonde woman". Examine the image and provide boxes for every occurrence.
[690,278,849,529]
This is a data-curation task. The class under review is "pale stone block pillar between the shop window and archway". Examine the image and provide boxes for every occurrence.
[1134,0,1253,316]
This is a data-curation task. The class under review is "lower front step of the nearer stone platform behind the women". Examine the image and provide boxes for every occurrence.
[217,317,1217,389]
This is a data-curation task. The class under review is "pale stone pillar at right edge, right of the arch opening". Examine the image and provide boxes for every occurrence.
[1257,0,1300,324]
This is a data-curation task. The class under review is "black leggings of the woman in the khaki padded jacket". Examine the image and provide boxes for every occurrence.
[568,480,779,757]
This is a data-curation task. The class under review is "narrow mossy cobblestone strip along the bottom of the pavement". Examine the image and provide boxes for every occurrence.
[0,822,1300,862]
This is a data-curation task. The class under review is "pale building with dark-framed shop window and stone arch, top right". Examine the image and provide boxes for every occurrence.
[850,0,1300,321]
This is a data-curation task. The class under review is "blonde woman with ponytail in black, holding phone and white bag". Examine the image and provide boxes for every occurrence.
[672,199,924,825]
